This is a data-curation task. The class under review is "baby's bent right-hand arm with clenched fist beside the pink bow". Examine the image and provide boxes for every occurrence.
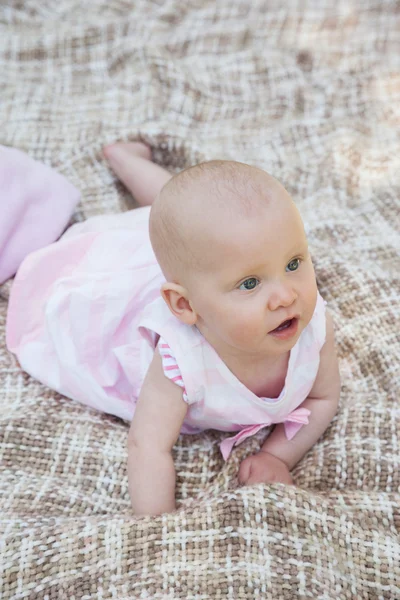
[239,313,340,484]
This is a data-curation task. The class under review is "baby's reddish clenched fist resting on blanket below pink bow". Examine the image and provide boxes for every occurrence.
[238,451,293,485]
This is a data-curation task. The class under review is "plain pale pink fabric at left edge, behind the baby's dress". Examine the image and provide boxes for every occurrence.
[0,146,80,284]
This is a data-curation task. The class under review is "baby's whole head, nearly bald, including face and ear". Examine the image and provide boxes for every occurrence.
[150,161,317,354]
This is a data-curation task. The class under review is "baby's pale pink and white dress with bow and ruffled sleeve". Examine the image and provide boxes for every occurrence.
[7,207,325,458]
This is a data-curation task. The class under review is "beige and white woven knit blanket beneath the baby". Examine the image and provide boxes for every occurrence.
[0,0,400,600]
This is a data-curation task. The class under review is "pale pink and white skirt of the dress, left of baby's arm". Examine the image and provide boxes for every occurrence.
[6,207,164,420]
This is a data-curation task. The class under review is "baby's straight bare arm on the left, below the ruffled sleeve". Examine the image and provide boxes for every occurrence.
[128,349,187,515]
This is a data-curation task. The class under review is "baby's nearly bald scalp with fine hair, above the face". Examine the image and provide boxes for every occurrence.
[150,160,292,283]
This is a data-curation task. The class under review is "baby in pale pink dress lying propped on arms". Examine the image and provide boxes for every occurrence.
[7,144,340,515]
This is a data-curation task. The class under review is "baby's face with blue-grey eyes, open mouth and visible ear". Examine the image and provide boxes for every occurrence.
[185,199,317,357]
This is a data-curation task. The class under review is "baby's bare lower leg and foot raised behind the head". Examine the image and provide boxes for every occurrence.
[103,142,172,206]
